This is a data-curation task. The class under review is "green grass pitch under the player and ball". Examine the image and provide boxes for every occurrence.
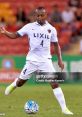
[0,84,82,117]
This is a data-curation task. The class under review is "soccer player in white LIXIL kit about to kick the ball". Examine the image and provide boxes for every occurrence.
[0,7,73,115]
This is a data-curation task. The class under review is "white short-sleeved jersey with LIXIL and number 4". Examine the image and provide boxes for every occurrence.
[17,21,58,62]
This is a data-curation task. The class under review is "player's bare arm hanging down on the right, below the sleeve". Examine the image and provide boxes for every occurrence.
[54,42,64,70]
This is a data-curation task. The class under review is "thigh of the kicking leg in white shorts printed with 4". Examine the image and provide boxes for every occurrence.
[19,61,37,80]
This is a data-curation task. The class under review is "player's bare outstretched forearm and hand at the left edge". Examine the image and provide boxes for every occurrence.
[0,27,20,39]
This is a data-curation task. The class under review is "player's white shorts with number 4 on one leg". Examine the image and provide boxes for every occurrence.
[19,59,55,80]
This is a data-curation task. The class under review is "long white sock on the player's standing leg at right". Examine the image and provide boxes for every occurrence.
[53,87,66,110]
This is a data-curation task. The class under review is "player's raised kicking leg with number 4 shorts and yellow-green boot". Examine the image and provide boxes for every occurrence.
[5,61,37,95]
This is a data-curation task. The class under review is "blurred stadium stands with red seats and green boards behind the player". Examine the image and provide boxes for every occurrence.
[0,0,82,82]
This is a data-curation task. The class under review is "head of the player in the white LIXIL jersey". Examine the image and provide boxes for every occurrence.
[35,7,47,25]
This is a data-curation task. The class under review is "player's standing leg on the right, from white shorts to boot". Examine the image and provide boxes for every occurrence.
[40,60,73,114]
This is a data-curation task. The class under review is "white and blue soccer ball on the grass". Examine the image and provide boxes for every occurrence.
[24,100,39,114]
